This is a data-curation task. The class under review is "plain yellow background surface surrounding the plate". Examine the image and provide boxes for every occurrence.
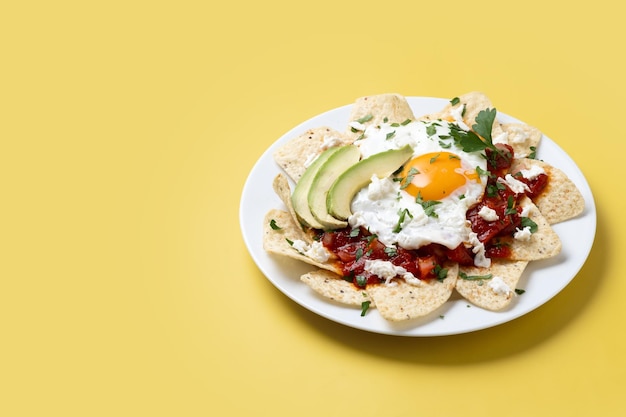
[0,0,626,417]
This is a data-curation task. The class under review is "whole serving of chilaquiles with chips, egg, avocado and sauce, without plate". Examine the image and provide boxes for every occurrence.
[263,93,584,321]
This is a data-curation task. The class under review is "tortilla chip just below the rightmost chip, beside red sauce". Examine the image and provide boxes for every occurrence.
[508,197,562,261]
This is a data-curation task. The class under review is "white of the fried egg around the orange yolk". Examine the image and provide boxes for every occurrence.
[348,121,487,249]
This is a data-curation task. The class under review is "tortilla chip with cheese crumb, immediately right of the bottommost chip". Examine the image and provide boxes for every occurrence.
[455,260,528,311]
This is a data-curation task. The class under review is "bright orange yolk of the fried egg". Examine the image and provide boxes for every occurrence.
[398,152,480,201]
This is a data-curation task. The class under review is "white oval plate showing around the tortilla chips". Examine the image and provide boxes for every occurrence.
[239,97,596,336]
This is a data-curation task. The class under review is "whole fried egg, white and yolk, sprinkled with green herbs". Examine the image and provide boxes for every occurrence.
[348,120,487,249]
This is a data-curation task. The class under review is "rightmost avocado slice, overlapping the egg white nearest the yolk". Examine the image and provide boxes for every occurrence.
[326,145,413,220]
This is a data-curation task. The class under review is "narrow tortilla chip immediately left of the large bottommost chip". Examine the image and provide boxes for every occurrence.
[300,269,374,308]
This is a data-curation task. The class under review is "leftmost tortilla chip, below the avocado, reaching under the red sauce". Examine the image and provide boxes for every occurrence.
[263,209,341,273]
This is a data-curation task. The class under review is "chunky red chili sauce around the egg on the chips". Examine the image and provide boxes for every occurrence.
[318,145,548,288]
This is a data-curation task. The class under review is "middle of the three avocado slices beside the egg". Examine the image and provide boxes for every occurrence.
[308,145,361,229]
